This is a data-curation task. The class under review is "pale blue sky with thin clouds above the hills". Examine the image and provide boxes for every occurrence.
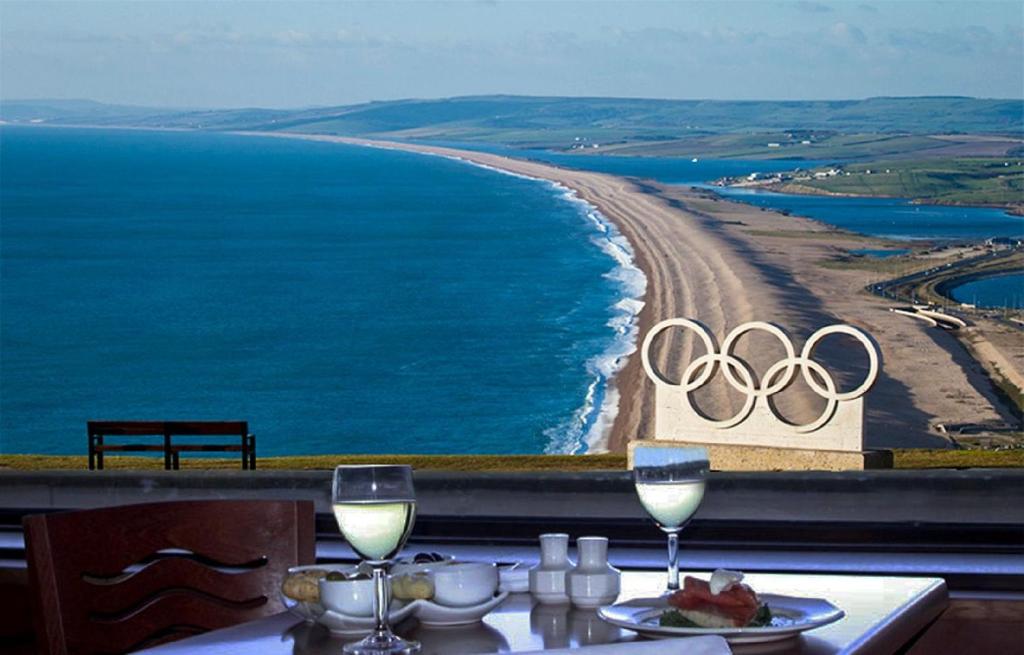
[0,0,1024,107]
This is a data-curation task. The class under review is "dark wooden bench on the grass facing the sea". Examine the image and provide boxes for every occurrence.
[88,421,256,471]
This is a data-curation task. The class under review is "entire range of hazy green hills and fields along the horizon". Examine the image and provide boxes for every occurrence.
[0,95,1024,157]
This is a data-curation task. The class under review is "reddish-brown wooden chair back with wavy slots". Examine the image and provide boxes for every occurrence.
[24,500,315,655]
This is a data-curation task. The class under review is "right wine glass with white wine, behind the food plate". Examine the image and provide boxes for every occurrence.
[633,444,709,592]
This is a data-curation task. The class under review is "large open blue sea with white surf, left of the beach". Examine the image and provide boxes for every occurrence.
[0,127,644,455]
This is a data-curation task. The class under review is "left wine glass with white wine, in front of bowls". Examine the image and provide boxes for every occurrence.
[331,465,420,655]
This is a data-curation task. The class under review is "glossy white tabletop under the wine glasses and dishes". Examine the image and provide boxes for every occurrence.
[134,571,948,655]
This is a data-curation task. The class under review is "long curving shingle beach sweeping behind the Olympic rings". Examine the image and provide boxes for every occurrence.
[247,132,1006,452]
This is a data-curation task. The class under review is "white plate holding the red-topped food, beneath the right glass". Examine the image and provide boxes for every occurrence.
[597,594,846,644]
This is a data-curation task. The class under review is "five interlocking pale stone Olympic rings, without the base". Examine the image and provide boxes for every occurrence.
[641,318,881,433]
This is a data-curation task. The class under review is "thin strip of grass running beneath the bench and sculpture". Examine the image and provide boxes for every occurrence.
[0,448,1024,472]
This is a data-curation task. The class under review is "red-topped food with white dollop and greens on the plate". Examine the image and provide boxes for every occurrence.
[658,569,771,627]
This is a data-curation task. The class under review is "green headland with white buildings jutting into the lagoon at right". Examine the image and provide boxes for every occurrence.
[781,158,1024,206]
